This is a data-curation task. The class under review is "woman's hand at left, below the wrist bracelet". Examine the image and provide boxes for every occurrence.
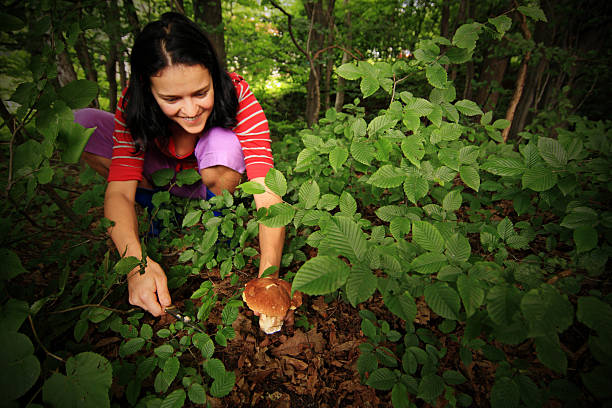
[128,257,172,316]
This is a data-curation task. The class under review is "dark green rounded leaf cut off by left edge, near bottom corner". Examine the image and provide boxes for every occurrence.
[0,330,40,402]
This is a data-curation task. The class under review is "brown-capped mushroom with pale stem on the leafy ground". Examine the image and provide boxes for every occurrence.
[242,278,302,334]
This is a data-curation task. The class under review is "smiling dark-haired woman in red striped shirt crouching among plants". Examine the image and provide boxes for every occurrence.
[75,13,285,316]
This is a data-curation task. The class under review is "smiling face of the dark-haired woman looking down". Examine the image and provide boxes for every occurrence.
[151,64,215,134]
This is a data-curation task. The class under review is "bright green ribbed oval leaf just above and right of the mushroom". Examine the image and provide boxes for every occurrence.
[292,255,350,295]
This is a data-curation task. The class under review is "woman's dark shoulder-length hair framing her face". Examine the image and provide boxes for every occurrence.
[121,12,238,152]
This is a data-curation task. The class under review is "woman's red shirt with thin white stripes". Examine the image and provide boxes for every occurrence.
[108,73,274,181]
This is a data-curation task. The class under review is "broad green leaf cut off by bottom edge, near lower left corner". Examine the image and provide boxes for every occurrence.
[43,352,113,408]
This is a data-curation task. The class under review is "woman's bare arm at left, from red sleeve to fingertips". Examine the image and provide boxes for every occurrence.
[104,180,172,316]
